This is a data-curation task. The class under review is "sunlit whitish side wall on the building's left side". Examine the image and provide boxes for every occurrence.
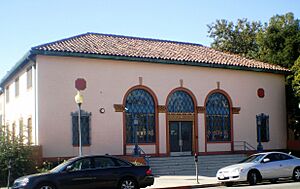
[0,64,37,144]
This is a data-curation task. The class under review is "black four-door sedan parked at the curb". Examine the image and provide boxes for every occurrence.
[12,155,154,189]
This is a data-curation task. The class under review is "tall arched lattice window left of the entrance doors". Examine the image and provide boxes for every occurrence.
[125,89,155,144]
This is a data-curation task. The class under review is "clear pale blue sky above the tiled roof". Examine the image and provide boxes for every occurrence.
[0,0,300,79]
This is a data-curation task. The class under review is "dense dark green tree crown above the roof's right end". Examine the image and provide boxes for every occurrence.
[257,13,300,68]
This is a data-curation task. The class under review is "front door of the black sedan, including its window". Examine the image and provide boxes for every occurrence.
[58,158,96,189]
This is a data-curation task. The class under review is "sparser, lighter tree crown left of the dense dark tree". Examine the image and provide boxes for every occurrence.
[208,19,262,58]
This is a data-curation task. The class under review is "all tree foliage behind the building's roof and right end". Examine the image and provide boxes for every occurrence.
[208,13,300,139]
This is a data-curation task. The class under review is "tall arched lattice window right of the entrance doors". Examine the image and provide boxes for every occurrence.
[206,92,231,142]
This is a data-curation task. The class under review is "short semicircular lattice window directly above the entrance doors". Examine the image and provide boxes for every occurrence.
[168,91,194,113]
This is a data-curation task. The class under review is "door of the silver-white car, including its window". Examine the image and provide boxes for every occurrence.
[259,153,281,179]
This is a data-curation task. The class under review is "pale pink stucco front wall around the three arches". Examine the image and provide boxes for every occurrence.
[36,56,287,157]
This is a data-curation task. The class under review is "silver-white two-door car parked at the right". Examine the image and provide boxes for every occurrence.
[216,152,300,186]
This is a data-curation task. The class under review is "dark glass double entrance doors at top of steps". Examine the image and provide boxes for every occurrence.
[169,121,193,156]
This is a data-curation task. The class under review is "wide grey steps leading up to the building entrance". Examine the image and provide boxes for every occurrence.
[149,154,246,177]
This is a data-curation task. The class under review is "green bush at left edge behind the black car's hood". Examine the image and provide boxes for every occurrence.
[0,126,34,186]
